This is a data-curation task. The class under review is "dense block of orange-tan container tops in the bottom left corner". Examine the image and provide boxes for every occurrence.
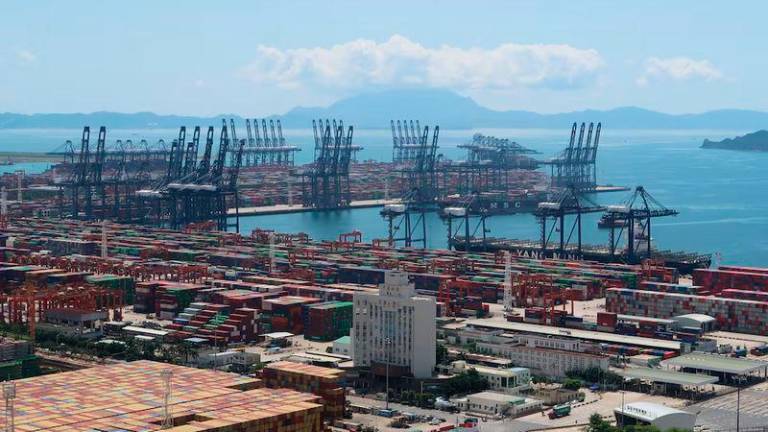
[2,361,322,432]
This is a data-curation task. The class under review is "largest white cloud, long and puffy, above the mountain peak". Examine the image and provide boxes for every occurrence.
[241,35,603,90]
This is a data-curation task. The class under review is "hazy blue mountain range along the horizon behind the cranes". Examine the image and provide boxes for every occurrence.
[0,90,768,130]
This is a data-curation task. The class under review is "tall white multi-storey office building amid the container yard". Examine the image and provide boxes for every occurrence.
[350,271,437,378]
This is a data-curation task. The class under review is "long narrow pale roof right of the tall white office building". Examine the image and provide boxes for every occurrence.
[467,319,680,351]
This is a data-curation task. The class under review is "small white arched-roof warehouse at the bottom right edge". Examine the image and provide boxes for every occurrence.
[613,402,696,430]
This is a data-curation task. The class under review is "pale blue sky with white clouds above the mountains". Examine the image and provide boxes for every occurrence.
[0,0,768,116]
